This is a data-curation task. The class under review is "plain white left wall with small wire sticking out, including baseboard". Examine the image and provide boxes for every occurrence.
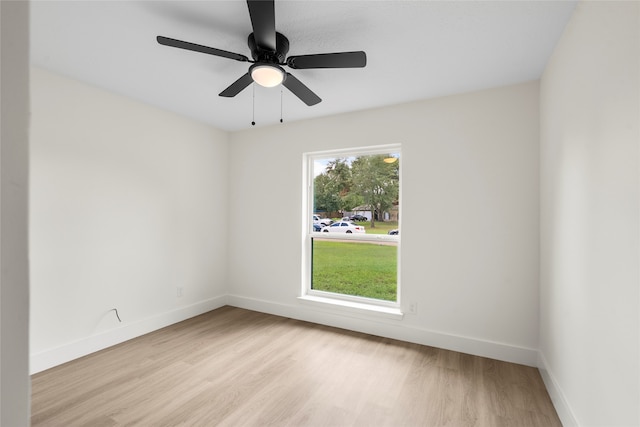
[30,69,228,372]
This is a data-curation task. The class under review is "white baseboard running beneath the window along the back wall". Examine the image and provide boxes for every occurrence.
[227,295,538,367]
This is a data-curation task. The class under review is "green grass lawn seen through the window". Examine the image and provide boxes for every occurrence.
[312,239,398,301]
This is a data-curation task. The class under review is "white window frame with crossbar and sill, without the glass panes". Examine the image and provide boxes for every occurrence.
[300,144,402,317]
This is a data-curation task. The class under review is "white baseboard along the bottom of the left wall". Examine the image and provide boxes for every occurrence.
[30,295,227,374]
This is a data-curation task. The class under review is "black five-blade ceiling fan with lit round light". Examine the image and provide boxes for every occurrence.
[156,0,367,106]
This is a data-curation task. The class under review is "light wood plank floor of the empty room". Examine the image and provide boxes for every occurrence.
[31,307,561,427]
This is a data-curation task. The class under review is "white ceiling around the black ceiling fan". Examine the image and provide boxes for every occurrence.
[31,0,576,131]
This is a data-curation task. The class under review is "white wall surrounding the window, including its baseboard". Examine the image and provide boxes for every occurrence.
[229,82,539,365]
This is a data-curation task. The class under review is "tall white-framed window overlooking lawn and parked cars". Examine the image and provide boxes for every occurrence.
[303,145,401,307]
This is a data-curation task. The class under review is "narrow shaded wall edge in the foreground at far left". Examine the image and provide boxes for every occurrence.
[0,1,31,427]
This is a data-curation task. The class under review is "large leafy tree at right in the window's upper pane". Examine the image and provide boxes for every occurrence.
[351,154,400,228]
